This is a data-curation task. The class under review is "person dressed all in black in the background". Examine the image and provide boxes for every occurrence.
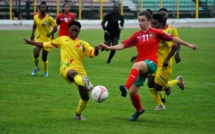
[101,4,124,64]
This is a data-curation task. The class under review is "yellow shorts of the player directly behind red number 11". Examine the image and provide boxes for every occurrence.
[154,68,171,86]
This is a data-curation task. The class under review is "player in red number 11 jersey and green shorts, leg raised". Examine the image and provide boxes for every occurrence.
[100,11,197,121]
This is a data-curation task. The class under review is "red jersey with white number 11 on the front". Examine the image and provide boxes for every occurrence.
[122,28,173,65]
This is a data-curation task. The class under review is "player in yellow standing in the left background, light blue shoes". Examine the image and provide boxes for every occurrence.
[31,2,57,76]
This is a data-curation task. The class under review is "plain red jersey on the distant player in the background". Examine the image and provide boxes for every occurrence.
[56,12,75,37]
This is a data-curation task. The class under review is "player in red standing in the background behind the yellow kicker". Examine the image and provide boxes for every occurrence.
[56,3,75,37]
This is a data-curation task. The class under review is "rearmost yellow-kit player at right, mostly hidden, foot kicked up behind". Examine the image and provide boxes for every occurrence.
[158,8,185,102]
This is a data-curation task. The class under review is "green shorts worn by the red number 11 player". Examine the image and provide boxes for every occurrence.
[134,60,157,87]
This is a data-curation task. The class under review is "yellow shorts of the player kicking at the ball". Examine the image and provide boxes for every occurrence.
[60,67,87,84]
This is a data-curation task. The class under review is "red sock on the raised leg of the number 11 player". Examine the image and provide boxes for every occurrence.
[125,68,139,90]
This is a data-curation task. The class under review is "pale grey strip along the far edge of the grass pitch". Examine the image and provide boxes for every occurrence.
[0,18,215,30]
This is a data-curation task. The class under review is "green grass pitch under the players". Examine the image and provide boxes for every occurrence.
[0,28,215,134]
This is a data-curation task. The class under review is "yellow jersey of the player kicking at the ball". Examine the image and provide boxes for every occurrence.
[43,36,95,73]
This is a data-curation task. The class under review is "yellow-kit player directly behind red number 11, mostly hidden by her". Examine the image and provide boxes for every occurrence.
[148,13,178,110]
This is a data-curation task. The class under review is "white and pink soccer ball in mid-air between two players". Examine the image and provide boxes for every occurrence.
[91,85,109,103]
